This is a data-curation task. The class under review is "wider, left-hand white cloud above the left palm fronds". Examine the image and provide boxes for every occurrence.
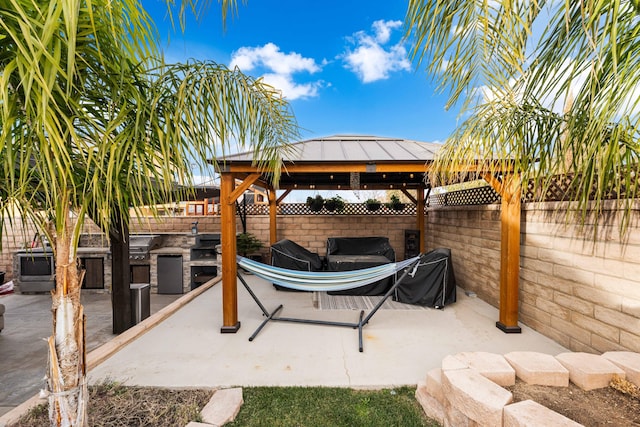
[229,43,323,100]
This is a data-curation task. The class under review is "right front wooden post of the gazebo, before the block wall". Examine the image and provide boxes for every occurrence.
[496,175,522,333]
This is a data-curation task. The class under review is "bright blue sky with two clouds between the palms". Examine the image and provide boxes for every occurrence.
[143,0,457,142]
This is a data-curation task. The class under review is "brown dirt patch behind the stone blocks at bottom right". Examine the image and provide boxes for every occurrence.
[506,379,640,427]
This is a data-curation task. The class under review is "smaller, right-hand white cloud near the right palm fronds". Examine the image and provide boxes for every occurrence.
[342,20,411,83]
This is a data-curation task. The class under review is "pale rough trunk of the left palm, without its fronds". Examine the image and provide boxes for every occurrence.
[47,206,88,426]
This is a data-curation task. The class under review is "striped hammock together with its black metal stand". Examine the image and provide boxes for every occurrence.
[237,255,420,352]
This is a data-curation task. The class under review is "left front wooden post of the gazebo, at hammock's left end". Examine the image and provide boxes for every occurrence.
[220,172,240,333]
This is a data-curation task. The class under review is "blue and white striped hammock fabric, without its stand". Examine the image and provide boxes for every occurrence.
[237,255,420,291]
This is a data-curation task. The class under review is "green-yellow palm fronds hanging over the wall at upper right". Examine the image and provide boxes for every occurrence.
[406,0,640,234]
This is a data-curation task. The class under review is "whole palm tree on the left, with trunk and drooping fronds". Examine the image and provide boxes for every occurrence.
[0,0,297,425]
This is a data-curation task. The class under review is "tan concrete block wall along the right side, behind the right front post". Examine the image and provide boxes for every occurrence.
[426,203,640,353]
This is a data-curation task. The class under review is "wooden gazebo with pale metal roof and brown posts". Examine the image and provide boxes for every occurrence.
[214,135,520,333]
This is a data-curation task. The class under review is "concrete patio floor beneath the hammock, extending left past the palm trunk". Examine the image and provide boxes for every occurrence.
[0,275,567,424]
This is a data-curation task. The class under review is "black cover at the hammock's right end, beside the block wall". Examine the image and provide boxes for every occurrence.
[394,248,456,308]
